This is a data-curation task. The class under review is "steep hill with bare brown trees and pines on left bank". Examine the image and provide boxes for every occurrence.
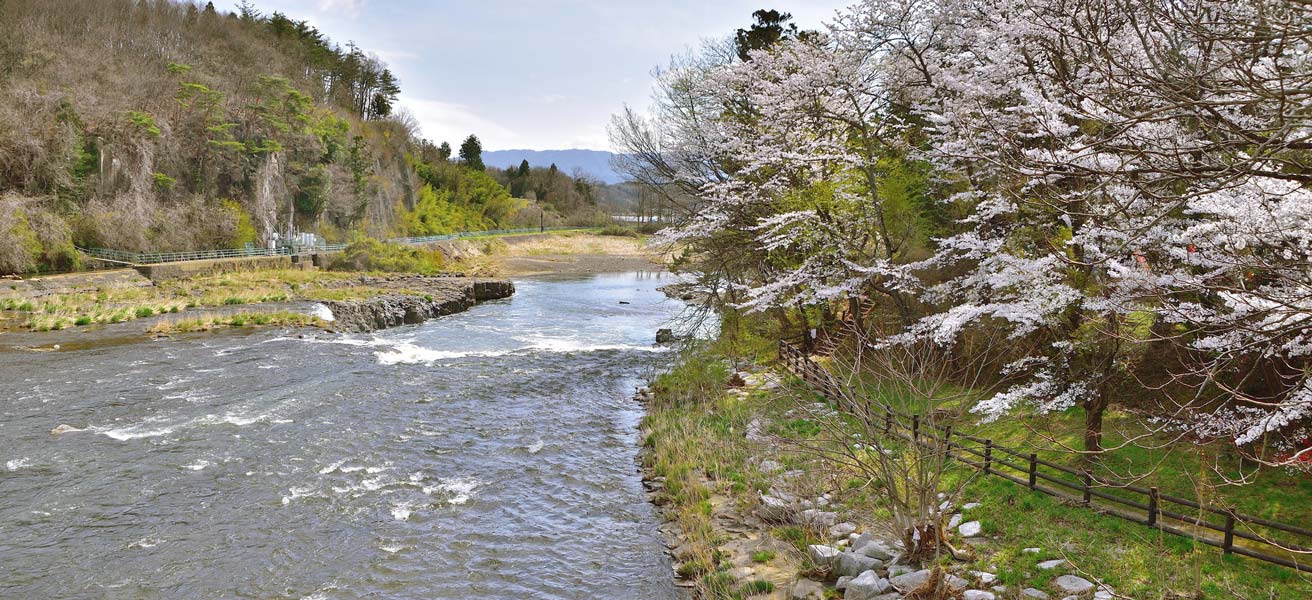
[0,0,537,273]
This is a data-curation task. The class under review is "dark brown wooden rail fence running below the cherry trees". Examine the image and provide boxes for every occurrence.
[779,341,1312,572]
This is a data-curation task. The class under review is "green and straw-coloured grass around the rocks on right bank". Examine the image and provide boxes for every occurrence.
[644,326,1312,599]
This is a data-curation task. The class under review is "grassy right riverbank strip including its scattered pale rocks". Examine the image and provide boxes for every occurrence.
[640,311,1312,599]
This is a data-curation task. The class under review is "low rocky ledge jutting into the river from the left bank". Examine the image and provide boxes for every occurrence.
[323,276,514,333]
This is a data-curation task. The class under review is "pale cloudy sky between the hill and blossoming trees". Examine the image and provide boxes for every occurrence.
[242,0,855,150]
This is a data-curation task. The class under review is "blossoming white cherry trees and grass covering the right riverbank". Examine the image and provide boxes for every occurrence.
[611,5,1312,599]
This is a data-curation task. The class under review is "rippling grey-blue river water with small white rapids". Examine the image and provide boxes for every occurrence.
[0,273,682,600]
